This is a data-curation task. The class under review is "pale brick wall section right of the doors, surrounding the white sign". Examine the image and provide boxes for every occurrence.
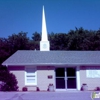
[80,66,100,90]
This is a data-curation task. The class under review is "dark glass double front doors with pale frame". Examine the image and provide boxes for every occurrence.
[55,67,76,89]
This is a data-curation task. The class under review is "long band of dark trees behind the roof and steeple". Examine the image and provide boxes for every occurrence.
[0,27,100,64]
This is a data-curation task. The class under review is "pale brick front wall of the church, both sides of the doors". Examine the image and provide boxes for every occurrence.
[8,66,100,91]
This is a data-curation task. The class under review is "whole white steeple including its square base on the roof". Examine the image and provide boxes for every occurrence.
[40,6,50,51]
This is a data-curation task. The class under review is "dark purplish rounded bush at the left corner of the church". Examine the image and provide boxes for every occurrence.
[0,66,18,91]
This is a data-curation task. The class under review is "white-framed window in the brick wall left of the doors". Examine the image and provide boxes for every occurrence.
[25,67,37,85]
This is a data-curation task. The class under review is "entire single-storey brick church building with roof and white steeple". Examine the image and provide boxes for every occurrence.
[2,7,100,91]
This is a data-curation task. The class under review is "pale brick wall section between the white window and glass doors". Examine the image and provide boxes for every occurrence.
[37,66,55,91]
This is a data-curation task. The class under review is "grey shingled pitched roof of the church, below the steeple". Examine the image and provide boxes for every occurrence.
[2,50,100,65]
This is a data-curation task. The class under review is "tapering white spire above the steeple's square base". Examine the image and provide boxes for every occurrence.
[42,6,48,41]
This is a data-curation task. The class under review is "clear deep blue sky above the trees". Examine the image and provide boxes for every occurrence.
[0,0,100,37]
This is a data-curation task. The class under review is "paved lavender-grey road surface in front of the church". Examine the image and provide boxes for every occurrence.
[0,91,92,100]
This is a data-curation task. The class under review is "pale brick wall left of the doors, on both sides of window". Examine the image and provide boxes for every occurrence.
[8,66,55,91]
